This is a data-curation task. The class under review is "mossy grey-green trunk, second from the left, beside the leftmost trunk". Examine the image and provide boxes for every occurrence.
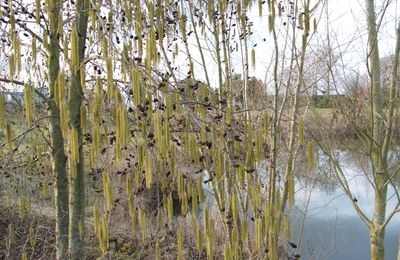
[69,0,89,259]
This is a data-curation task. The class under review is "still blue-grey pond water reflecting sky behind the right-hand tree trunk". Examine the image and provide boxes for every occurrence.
[292,148,400,260]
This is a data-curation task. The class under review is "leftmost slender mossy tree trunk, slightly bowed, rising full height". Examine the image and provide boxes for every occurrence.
[48,1,69,259]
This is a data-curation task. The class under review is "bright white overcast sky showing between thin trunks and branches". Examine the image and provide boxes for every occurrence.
[173,0,400,89]
